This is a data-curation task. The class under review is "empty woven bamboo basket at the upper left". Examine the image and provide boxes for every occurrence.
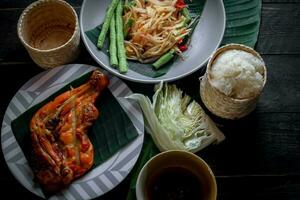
[18,0,80,69]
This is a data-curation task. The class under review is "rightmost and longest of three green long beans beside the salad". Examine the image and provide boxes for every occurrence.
[116,1,128,73]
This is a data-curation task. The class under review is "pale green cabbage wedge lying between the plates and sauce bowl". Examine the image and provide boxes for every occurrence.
[128,83,225,153]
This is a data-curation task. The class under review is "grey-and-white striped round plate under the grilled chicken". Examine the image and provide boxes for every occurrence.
[1,64,144,199]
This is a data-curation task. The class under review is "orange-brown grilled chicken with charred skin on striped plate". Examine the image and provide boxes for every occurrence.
[30,70,109,192]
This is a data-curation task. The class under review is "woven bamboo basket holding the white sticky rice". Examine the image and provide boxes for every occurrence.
[200,44,267,119]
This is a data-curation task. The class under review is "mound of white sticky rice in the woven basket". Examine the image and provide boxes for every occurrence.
[210,50,265,99]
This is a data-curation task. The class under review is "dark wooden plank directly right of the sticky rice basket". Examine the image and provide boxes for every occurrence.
[257,55,300,113]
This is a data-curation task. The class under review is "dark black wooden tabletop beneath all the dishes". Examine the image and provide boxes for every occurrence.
[0,0,300,200]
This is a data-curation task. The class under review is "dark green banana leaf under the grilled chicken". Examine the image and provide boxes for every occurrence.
[11,72,138,195]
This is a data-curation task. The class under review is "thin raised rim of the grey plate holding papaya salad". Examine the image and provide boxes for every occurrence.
[79,0,226,84]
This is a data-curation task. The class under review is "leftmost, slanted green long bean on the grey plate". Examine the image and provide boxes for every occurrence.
[97,0,120,49]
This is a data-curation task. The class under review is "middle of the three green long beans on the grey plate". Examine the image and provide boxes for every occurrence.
[109,12,118,67]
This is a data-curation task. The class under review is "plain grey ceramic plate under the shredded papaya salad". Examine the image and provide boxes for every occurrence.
[80,0,226,83]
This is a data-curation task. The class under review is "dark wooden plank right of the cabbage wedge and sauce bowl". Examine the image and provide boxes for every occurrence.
[197,112,300,176]
